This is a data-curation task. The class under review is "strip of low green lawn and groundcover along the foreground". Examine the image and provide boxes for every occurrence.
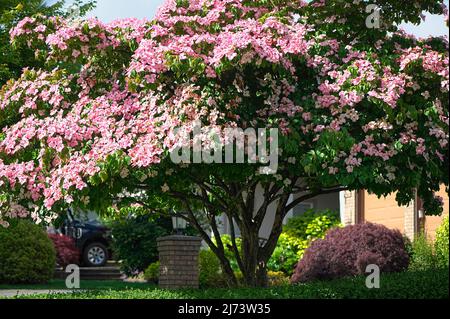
[0,269,449,299]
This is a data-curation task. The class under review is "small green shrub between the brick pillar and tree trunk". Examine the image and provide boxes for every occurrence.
[199,249,226,287]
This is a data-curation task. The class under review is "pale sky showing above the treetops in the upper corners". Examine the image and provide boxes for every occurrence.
[49,0,448,37]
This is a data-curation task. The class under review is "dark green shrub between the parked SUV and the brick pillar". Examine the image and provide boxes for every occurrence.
[109,216,172,276]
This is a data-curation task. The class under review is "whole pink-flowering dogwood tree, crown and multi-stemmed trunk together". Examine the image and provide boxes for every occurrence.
[0,0,449,285]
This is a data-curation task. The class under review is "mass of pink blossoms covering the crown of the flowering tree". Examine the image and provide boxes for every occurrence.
[0,0,449,222]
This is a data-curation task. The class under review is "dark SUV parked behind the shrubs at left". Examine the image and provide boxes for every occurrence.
[60,210,111,267]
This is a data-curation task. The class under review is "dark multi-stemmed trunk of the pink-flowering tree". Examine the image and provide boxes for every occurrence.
[179,178,347,287]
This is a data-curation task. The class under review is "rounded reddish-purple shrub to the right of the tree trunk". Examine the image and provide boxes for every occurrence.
[291,223,409,283]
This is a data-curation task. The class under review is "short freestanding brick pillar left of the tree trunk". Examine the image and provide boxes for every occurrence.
[157,235,202,289]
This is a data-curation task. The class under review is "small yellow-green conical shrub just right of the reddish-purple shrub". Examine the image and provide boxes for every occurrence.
[409,234,437,271]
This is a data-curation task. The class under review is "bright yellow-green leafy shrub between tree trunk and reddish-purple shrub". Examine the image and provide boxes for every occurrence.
[267,210,340,276]
